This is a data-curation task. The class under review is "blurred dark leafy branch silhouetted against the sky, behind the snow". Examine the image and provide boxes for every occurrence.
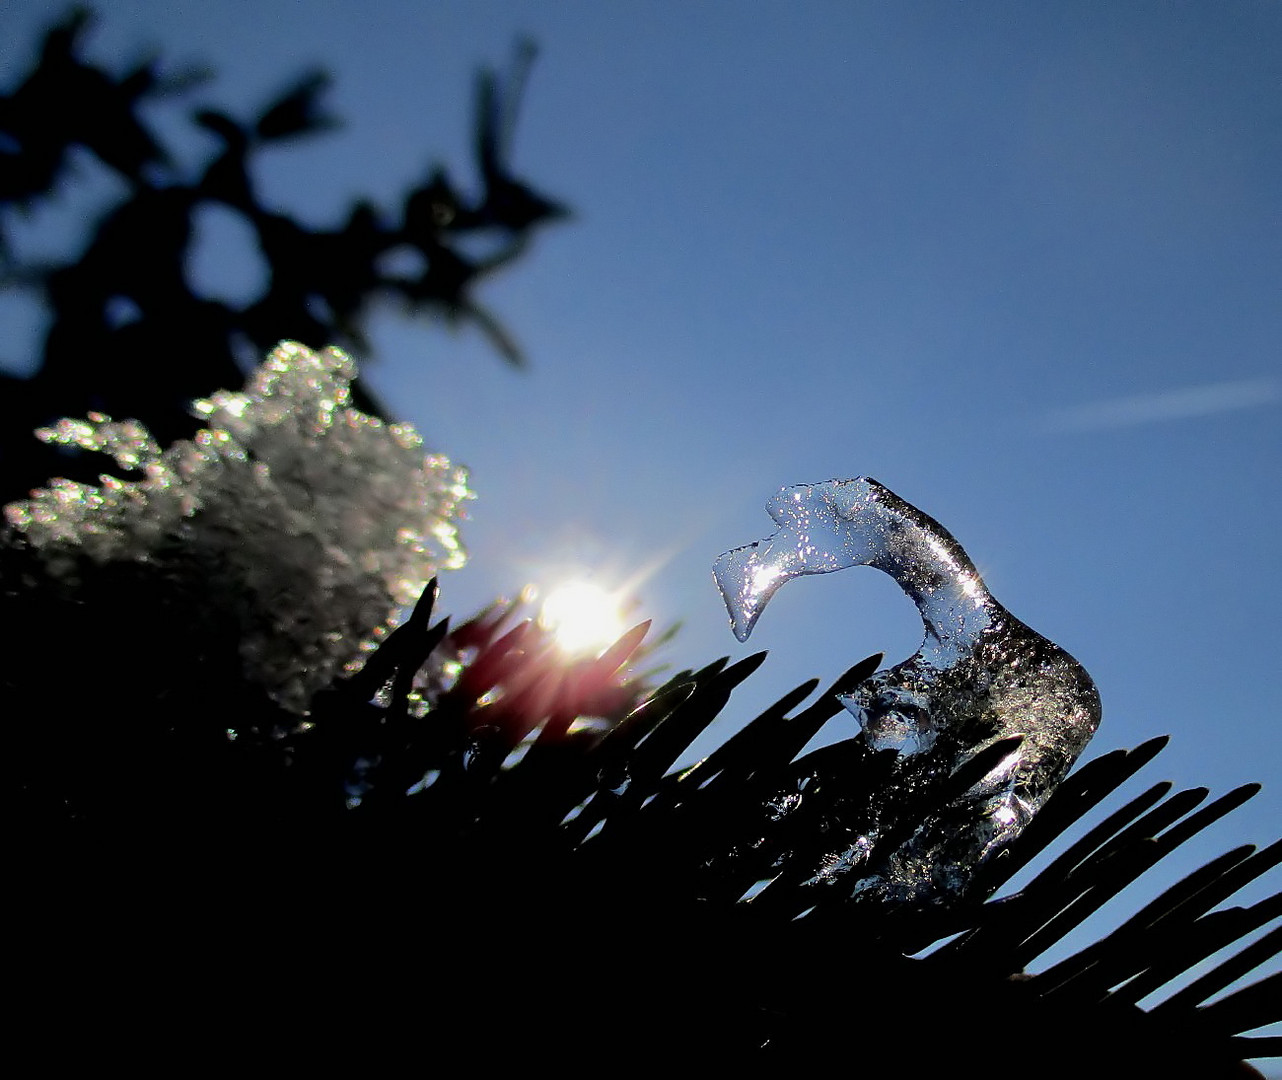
[0,9,567,499]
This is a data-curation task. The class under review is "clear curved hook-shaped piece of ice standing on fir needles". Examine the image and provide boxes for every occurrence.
[714,477,1100,900]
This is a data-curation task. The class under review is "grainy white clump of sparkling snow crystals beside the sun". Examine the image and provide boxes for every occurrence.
[5,342,472,713]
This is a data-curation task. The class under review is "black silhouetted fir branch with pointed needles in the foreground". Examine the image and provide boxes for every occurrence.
[4,564,1282,1076]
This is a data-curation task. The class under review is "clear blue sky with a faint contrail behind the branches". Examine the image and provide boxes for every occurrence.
[0,0,1282,1041]
